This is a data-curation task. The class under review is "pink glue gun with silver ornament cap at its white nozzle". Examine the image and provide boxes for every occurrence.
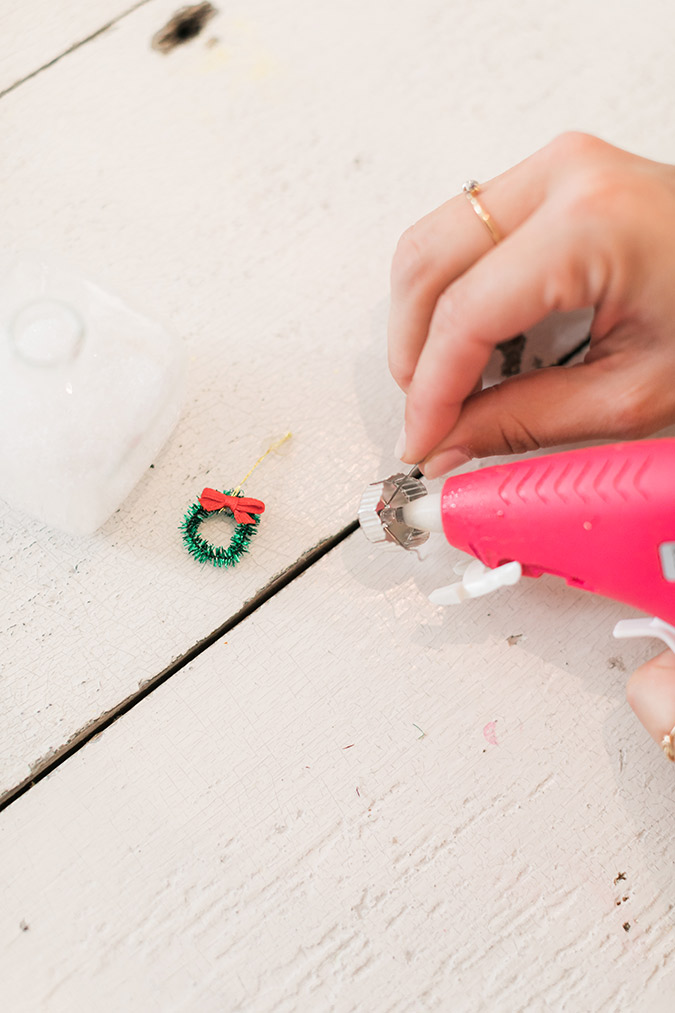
[359,440,675,650]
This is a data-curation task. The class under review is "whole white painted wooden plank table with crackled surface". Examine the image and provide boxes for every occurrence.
[0,0,675,1011]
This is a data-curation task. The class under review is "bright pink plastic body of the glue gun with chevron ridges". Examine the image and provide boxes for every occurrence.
[441,440,675,623]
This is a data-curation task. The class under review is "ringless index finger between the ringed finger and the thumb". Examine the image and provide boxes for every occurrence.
[402,205,606,463]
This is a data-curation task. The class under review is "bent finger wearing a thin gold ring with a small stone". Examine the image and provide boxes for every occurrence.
[388,151,552,391]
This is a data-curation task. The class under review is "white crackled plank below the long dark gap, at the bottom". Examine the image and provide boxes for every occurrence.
[0,533,675,1013]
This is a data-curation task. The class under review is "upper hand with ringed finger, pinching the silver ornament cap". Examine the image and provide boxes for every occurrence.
[389,134,675,478]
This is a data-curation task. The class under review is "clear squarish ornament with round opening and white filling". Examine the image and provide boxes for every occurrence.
[0,253,184,534]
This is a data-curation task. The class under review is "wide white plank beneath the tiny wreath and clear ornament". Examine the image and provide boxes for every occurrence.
[0,0,675,793]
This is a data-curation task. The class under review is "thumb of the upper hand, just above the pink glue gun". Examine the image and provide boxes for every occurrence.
[422,359,647,478]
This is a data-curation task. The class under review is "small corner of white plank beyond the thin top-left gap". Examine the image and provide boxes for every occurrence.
[0,0,149,97]
